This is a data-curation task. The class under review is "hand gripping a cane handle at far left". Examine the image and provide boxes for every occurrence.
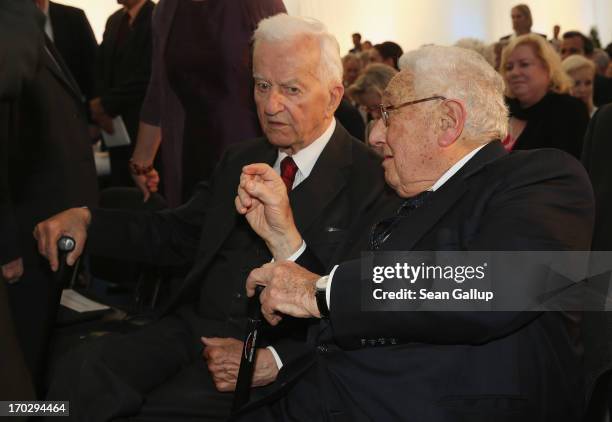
[34,208,91,271]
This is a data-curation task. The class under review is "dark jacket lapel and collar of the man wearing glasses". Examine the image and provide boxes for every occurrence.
[383,141,506,250]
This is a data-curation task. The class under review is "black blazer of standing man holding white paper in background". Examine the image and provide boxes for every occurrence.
[94,0,155,142]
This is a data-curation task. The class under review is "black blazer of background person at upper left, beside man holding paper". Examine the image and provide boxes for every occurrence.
[49,2,98,99]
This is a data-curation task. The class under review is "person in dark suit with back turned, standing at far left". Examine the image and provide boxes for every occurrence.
[0,0,98,395]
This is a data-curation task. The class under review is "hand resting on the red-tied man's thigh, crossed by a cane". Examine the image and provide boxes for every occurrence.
[202,337,278,391]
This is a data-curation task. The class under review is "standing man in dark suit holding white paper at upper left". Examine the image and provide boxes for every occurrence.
[89,0,155,186]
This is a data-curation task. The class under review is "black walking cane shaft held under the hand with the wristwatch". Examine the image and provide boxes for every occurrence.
[232,286,264,413]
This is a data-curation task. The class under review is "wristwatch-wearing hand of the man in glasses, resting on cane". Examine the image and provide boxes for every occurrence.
[246,261,321,325]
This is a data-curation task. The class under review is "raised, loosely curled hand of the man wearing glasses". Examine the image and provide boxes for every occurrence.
[235,164,302,260]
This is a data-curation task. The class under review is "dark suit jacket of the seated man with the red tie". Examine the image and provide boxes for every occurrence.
[88,124,385,361]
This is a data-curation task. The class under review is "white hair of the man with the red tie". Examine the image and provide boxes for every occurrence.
[253,13,343,84]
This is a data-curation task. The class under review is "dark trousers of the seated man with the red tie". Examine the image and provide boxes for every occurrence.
[47,316,233,422]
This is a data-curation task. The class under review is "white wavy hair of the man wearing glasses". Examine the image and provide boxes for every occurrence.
[399,45,508,142]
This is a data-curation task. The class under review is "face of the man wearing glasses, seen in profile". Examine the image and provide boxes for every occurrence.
[371,70,440,197]
